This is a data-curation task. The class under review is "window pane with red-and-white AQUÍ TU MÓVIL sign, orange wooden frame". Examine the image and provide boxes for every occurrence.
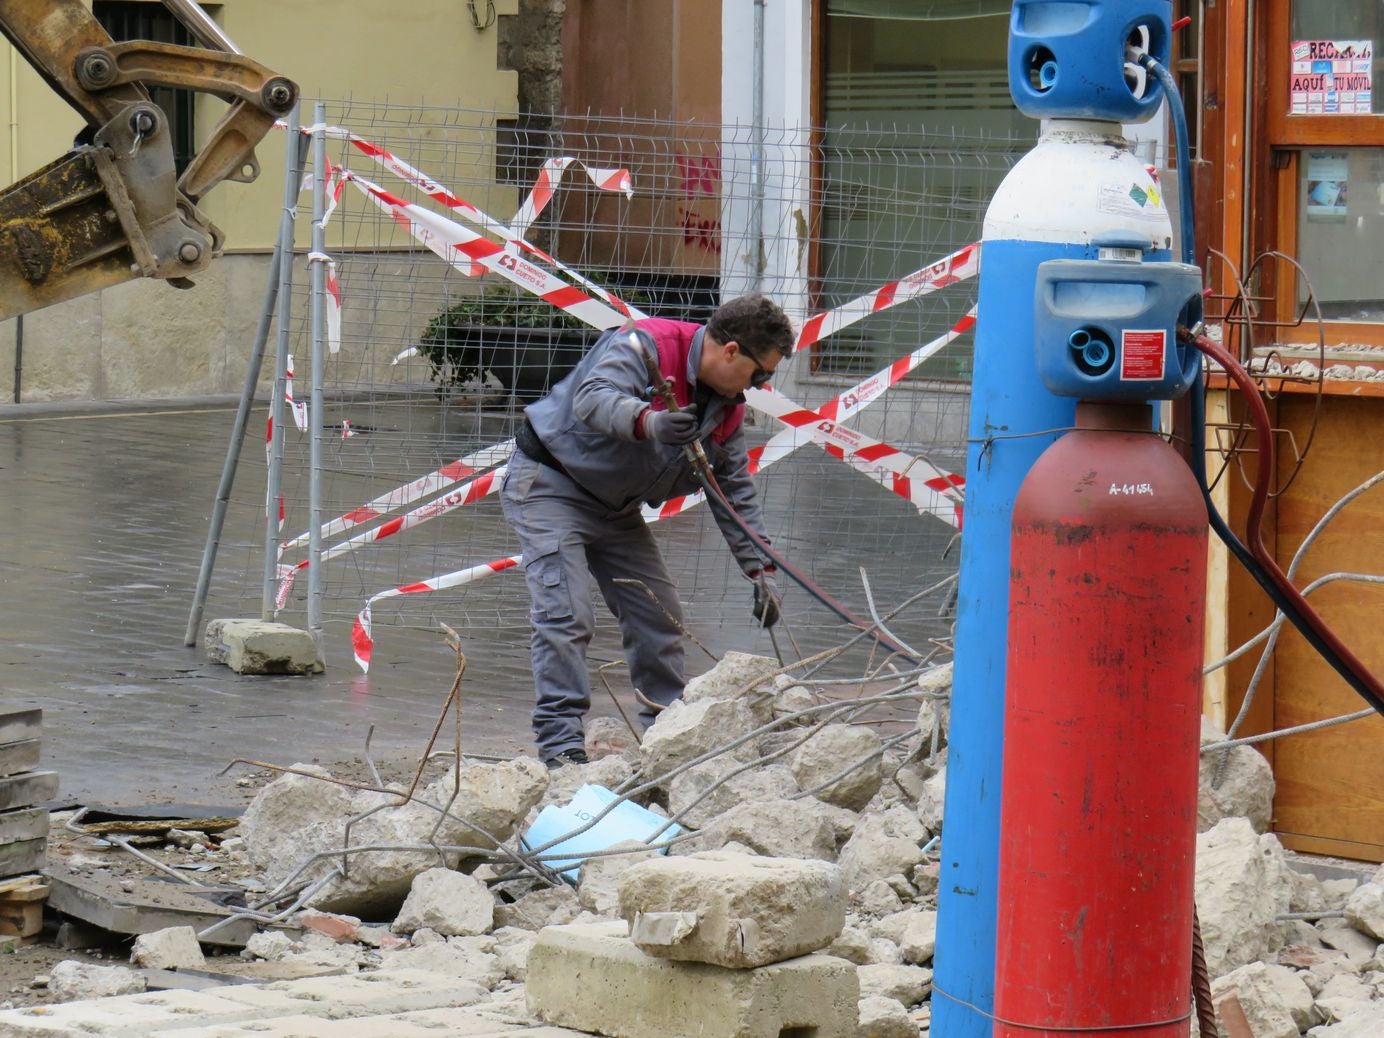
[1289,0,1384,115]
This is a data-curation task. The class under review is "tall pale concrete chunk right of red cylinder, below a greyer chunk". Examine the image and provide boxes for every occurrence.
[1196,818,1291,977]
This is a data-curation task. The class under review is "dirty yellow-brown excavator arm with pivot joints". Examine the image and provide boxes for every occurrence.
[0,0,298,320]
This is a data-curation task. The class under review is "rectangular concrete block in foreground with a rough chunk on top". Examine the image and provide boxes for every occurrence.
[527,923,859,1038]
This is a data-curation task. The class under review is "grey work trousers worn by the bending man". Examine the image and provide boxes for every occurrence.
[500,450,685,758]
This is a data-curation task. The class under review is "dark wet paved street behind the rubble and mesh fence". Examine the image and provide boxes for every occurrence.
[0,401,956,804]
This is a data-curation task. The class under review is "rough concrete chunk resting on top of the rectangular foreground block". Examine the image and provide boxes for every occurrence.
[620,853,846,969]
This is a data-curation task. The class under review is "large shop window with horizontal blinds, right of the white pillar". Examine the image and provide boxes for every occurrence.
[817,0,1038,379]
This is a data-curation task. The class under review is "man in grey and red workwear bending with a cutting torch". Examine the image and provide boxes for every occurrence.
[500,293,793,768]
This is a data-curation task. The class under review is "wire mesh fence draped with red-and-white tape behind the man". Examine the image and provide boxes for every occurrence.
[218,102,1031,694]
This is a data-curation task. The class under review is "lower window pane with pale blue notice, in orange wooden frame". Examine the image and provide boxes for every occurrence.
[1298,148,1384,321]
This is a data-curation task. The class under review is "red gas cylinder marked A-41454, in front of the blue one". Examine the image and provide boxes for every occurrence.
[994,403,1207,1038]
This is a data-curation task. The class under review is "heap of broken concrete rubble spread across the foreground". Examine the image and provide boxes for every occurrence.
[13,655,1384,1038]
